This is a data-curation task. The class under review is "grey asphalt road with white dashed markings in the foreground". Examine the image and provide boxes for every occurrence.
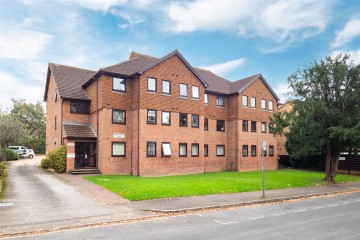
[11,193,360,240]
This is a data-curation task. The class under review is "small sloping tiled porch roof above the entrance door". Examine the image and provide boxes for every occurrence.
[63,121,96,138]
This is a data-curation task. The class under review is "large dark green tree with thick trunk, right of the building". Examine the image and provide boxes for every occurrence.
[271,54,360,183]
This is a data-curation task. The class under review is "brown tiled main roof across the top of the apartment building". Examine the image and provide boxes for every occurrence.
[45,50,280,101]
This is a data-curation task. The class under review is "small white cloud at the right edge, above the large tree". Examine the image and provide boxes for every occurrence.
[331,17,360,48]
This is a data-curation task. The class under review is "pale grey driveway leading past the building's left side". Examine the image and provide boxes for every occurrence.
[0,156,149,233]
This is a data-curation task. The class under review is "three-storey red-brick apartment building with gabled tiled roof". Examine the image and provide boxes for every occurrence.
[44,50,279,176]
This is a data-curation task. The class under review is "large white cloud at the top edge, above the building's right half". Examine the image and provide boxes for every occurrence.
[166,0,331,42]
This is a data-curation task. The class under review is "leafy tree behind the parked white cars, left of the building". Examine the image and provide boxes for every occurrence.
[10,99,46,152]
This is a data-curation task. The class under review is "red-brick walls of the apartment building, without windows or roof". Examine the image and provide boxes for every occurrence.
[46,50,278,176]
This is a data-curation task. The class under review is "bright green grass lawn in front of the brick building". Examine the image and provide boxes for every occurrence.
[84,170,360,201]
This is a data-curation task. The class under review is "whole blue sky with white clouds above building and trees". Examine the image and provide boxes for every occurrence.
[0,0,360,109]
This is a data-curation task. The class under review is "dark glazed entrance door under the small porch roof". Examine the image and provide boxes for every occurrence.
[75,142,96,168]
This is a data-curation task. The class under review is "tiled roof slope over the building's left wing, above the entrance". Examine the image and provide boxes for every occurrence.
[49,63,96,100]
